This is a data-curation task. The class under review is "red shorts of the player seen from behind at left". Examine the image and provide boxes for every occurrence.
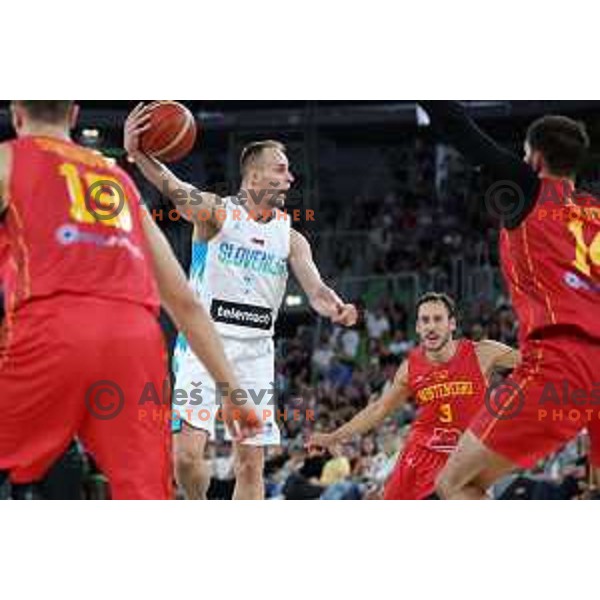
[0,296,172,499]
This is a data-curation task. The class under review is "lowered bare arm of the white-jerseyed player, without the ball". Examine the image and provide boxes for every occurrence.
[290,229,358,327]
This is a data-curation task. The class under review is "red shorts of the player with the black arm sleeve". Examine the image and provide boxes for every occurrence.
[470,335,600,468]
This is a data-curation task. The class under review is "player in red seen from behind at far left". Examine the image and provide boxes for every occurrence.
[0,101,255,499]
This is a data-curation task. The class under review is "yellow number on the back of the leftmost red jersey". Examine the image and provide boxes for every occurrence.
[59,163,132,231]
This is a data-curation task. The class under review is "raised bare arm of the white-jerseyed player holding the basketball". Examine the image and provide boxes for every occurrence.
[125,104,222,229]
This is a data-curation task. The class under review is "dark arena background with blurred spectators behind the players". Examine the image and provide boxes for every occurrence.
[0,101,600,499]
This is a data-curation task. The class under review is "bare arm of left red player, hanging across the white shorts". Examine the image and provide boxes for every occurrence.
[142,208,259,437]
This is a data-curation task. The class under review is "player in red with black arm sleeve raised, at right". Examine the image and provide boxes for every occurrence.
[422,102,600,499]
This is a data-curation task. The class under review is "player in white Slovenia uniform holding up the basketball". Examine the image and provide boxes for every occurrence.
[125,105,357,499]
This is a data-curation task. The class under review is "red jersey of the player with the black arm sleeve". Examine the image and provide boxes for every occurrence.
[500,179,600,343]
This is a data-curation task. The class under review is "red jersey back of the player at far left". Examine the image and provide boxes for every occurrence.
[4,136,159,310]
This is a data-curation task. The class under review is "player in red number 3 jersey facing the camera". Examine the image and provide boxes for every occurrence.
[309,292,519,500]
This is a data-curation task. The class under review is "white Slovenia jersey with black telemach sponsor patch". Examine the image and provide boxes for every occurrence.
[190,198,290,339]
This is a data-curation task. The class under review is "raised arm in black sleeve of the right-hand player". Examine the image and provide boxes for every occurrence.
[419,100,540,227]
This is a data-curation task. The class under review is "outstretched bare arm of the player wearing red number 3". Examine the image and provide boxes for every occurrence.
[308,361,411,449]
